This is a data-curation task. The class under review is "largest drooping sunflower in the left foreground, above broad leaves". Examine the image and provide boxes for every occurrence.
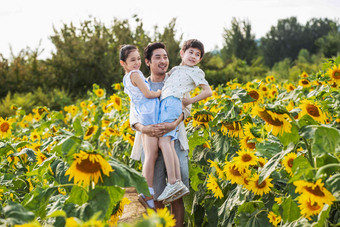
[65,151,113,187]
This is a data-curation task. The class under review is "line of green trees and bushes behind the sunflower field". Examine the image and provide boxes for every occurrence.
[0,16,340,112]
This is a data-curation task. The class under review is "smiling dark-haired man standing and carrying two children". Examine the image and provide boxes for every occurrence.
[130,43,191,226]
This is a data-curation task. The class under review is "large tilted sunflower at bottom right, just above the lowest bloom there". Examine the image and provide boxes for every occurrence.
[293,179,335,205]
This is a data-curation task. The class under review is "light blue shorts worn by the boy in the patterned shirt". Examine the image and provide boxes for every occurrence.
[158,96,182,140]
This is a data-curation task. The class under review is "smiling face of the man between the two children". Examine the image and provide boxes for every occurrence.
[145,48,169,75]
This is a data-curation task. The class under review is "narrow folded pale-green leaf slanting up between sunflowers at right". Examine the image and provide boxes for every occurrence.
[259,143,294,184]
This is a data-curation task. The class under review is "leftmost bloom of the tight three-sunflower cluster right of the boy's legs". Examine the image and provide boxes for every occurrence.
[223,162,250,185]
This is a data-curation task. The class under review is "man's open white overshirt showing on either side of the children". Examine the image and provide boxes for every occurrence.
[130,74,191,160]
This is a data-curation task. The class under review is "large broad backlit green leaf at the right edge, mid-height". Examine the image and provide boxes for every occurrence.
[312,126,340,157]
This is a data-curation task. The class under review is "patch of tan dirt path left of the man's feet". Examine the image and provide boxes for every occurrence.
[118,188,145,223]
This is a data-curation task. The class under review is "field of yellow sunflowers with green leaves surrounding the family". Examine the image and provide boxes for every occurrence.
[0,57,340,227]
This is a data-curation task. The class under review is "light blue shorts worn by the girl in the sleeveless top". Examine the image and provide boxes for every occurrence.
[135,98,159,125]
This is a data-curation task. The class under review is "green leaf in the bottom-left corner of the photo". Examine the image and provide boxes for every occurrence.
[3,200,35,225]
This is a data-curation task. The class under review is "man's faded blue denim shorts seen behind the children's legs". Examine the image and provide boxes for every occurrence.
[141,139,189,199]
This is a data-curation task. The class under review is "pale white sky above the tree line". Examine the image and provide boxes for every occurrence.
[0,0,340,59]
